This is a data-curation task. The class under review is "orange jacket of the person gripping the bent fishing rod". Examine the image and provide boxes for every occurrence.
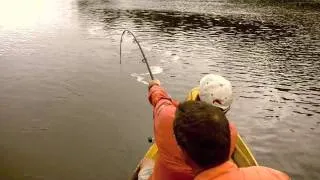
[148,85,237,180]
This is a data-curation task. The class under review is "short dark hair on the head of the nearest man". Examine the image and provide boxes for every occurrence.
[174,101,231,169]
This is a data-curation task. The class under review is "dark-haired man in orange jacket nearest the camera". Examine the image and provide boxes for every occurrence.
[173,101,289,180]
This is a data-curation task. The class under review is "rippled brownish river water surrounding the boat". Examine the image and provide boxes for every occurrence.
[0,0,320,180]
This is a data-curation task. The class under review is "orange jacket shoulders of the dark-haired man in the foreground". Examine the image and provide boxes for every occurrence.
[195,161,290,180]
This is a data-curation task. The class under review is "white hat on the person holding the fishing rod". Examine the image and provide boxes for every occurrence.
[199,74,232,111]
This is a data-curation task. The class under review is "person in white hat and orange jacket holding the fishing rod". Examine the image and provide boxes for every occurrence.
[141,76,238,180]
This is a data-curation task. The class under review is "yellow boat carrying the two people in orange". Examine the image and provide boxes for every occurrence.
[131,88,258,180]
